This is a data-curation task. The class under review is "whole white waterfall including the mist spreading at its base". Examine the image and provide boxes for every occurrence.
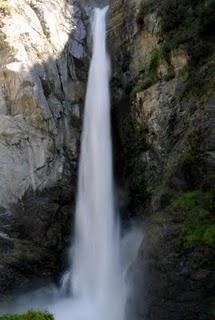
[0,7,142,320]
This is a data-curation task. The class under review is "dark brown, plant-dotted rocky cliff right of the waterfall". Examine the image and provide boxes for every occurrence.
[109,0,215,320]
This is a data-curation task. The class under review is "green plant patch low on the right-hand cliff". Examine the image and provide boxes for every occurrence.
[170,190,215,248]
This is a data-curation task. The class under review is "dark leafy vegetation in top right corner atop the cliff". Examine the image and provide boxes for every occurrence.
[159,0,215,99]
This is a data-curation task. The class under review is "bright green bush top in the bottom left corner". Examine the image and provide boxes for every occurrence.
[0,310,54,320]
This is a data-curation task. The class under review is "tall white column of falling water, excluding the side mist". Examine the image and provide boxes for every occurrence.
[72,7,125,320]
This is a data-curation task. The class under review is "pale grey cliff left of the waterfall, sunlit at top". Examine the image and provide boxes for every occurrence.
[0,0,87,300]
